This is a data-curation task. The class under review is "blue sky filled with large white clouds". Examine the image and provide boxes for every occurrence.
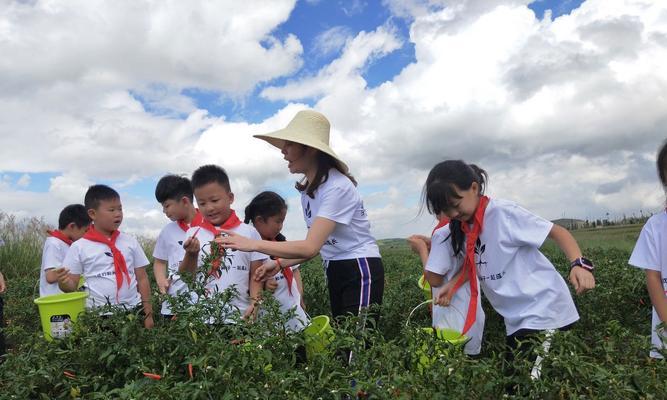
[0,0,667,239]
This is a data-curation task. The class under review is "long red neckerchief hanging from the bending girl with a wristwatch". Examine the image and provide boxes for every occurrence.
[452,196,489,334]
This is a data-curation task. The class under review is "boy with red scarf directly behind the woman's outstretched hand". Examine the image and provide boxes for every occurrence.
[179,165,268,322]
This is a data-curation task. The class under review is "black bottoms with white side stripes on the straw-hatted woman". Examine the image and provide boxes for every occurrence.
[326,257,384,318]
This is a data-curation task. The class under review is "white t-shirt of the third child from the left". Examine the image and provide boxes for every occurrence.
[153,222,197,315]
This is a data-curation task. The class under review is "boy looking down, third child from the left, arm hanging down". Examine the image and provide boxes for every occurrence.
[153,175,201,319]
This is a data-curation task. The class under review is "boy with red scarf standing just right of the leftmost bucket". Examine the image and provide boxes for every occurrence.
[57,185,153,328]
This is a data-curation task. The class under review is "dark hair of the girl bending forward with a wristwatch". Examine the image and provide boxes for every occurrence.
[422,160,489,255]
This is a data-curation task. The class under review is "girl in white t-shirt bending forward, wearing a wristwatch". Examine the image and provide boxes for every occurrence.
[424,160,595,375]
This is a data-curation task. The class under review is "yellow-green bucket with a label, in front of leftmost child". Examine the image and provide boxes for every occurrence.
[34,292,88,341]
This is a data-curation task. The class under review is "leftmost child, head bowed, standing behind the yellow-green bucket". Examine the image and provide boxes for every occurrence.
[39,204,90,296]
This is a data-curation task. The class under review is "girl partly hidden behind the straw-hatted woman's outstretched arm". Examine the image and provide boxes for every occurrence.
[244,191,308,331]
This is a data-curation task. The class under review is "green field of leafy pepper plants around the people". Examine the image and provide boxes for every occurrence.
[0,216,667,399]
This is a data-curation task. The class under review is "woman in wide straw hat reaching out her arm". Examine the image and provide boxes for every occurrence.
[222,110,384,324]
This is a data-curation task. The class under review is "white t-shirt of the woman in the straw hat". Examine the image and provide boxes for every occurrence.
[301,168,380,261]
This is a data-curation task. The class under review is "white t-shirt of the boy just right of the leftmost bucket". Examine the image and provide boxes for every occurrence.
[63,232,148,308]
